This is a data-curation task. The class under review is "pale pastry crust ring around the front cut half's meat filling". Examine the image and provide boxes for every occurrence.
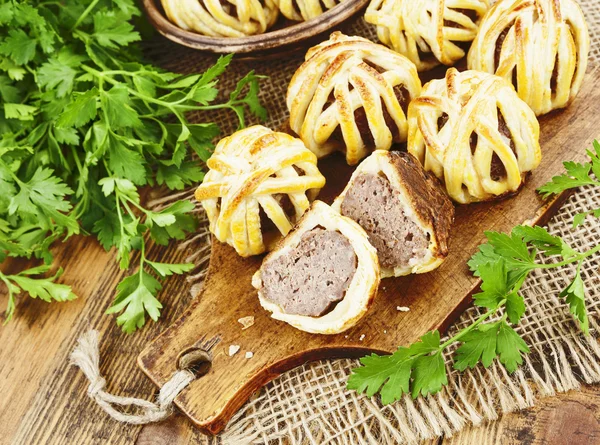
[252,201,380,334]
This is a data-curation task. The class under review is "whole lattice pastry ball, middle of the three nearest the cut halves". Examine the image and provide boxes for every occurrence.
[287,32,421,165]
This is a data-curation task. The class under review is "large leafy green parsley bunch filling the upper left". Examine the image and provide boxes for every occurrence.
[0,0,266,332]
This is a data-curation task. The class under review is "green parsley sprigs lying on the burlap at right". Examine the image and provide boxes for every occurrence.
[348,141,600,404]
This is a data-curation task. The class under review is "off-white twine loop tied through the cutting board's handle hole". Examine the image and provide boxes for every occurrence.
[70,329,204,425]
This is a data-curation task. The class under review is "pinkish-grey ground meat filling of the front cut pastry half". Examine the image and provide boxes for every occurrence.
[261,228,357,317]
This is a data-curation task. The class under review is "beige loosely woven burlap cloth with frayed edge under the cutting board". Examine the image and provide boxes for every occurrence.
[152,0,600,444]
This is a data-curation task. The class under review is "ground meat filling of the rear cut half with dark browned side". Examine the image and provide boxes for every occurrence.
[342,174,429,268]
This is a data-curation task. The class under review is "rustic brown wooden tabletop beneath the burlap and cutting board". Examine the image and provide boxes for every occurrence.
[0,237,600,445]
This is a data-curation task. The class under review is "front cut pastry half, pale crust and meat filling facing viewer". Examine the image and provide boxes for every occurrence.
[252,201,379,334]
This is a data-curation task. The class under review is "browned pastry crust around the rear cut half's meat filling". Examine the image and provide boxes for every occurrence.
[331,150,454,278]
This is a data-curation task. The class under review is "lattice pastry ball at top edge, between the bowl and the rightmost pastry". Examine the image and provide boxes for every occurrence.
[365,0,490,71]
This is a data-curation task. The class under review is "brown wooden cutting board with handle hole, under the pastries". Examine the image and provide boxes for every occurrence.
[138,68,600,434]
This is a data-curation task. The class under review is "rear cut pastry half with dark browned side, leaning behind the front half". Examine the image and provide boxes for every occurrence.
[332,150,454,278]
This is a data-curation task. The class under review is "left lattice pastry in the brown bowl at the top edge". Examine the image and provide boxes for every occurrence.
[161,0,279,37]
